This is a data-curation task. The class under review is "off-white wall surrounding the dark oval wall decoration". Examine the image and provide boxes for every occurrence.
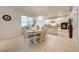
[0,7,22,39]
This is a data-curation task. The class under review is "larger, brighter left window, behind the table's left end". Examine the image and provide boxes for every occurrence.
[21,16,33,27]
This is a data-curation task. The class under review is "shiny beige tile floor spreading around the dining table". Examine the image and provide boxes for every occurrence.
[0,30,79,52]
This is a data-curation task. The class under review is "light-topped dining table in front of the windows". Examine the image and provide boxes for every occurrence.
[26,29,42,43]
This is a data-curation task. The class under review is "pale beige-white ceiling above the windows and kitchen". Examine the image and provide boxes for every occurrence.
[12,6,71,17]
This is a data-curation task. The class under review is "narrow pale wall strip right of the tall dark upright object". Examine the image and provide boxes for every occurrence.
[71,7,79,46]
